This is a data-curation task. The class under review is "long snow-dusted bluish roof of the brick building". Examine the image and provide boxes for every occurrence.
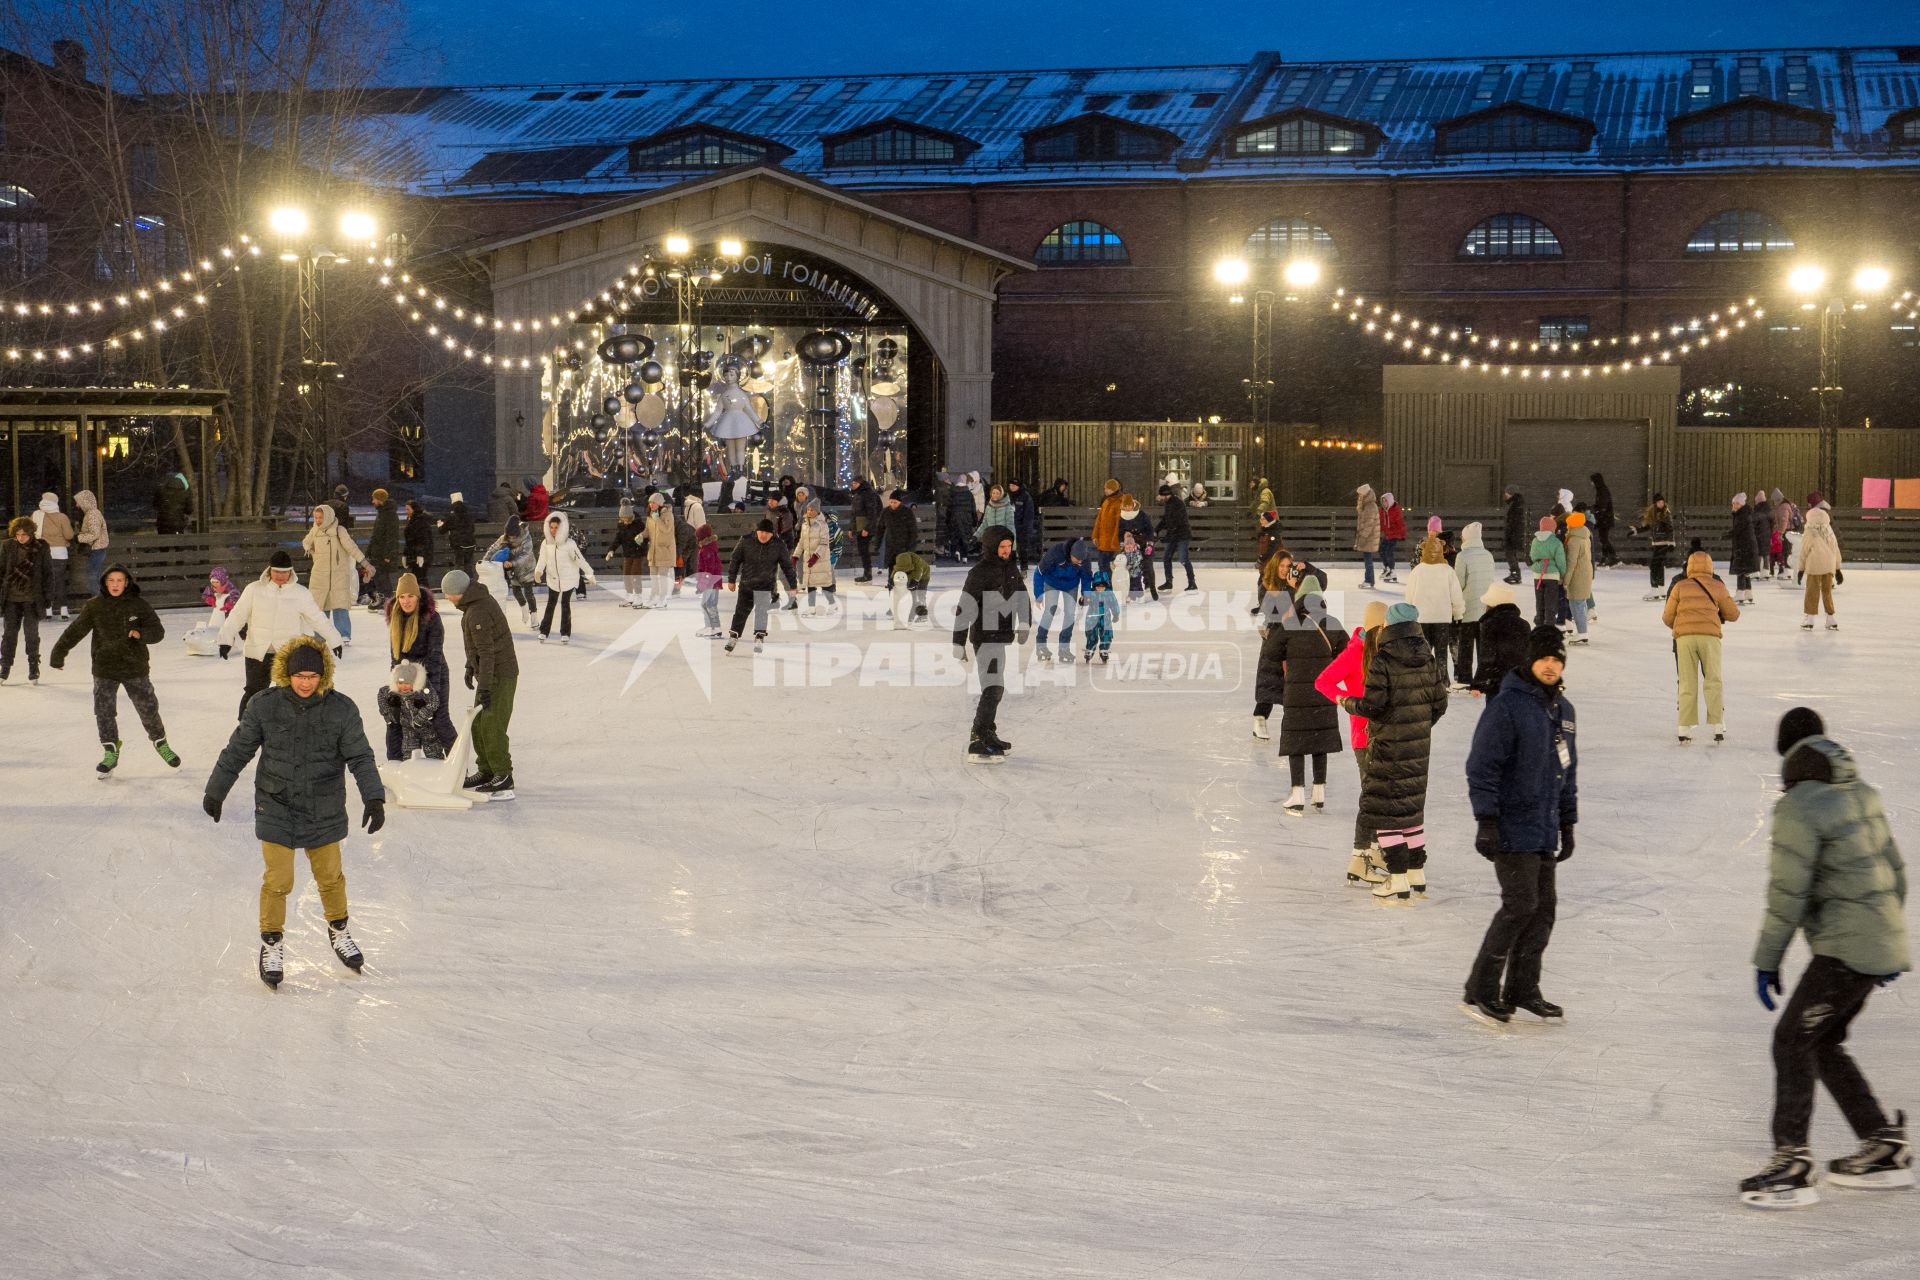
[337,48,1920,194]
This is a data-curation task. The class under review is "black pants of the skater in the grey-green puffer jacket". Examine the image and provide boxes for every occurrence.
[1774,956,1887,1148]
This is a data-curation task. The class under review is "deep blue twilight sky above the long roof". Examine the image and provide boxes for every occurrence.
[388,0,1920,84]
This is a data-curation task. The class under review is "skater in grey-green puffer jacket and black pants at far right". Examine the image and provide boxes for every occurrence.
[1740,706,1914,1209]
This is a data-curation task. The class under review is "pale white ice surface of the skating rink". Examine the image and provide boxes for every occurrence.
[0,568,1920,1280]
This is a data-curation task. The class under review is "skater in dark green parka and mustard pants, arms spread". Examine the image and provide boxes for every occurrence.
[200,635,386,986]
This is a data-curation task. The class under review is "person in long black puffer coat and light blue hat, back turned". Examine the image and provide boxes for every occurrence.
[1340,603,1448,902]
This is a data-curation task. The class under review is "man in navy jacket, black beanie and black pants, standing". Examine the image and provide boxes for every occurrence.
[1461,626,1580,1023]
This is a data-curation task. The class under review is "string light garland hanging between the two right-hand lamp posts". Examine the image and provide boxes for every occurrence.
[1331,290,1766,380]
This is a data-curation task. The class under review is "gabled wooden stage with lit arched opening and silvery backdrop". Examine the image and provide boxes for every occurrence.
[480,167,1025,502]
